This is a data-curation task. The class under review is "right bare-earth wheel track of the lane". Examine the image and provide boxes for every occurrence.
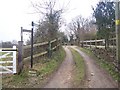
[71,46,117,88]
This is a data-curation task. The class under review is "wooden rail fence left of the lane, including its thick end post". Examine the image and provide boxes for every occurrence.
[18,38,61,72]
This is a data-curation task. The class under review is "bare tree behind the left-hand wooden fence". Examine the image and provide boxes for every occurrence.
[32,0,64,42]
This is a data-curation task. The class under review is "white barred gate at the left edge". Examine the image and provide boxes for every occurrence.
[0,46,17,74]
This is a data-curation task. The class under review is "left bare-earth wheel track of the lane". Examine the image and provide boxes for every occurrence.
[45,46,74,88]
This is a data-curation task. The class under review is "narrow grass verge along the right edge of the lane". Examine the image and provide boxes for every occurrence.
[79,48,120,81]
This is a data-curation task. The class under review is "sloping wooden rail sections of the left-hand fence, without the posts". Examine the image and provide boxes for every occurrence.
[23,39,60,60]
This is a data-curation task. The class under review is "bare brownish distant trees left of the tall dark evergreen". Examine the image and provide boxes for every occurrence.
[68,15,96,45]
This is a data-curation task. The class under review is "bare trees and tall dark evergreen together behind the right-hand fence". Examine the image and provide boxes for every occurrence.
[65,0,115,48]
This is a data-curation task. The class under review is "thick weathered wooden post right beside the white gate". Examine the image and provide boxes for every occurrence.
[18,41,23,74]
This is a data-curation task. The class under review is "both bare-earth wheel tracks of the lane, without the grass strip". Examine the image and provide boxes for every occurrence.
[45,46,117,88]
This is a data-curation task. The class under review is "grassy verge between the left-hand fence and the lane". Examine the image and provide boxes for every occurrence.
[3,47,66,88]
